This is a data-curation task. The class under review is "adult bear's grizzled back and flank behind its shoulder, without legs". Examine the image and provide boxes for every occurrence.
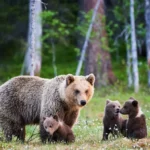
[0,76,47,124]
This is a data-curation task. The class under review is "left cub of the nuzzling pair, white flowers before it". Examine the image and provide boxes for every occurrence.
[102,100,125,140]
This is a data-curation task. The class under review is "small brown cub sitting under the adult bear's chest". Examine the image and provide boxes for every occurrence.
[43,115,75,143]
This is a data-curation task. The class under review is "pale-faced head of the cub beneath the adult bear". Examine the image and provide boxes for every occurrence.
[43,115,60,135]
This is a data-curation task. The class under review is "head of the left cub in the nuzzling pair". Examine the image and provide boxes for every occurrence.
[105,100,121,118]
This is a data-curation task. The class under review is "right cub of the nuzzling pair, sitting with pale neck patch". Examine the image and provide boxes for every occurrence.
[120,97,147,139]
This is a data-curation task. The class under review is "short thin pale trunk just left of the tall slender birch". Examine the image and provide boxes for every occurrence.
[125,31,133,87]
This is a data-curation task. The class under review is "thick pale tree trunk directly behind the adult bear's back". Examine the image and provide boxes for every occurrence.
[21,0,42,75]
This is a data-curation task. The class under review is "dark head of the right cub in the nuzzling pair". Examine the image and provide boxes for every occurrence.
[120,97,140,116]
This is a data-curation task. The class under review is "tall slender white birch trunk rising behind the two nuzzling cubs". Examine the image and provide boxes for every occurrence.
[130,0,139,93]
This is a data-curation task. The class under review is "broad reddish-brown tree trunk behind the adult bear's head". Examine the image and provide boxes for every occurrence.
[84,0,115,87]
